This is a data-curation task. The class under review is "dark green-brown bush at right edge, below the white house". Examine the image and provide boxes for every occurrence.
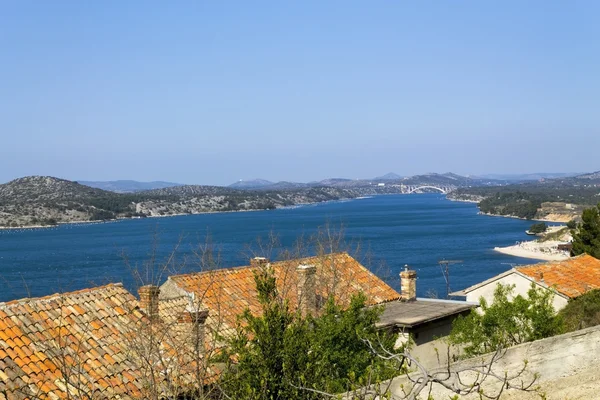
[558,289,600,332]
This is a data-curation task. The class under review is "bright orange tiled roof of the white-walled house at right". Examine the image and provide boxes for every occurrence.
[516,254,600,298]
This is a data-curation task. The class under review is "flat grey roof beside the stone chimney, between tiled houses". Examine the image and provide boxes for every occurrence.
[377,298,478,328]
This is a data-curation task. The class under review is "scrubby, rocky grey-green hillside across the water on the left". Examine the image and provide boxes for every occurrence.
[0,176,360,227]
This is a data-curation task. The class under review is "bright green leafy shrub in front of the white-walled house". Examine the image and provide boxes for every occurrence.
[450,283,563,356]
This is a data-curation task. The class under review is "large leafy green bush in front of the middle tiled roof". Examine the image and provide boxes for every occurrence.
[222,270,399,400]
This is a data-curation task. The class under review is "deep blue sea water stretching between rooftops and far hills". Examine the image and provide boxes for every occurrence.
[0,194,535,301]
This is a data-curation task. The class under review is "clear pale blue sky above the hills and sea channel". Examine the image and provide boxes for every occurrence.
[0,1,600,184]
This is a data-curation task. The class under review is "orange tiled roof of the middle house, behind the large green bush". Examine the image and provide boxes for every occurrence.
[159,253,400,336]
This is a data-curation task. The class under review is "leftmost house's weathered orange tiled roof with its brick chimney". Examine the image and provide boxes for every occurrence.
[0,284,214,400]
